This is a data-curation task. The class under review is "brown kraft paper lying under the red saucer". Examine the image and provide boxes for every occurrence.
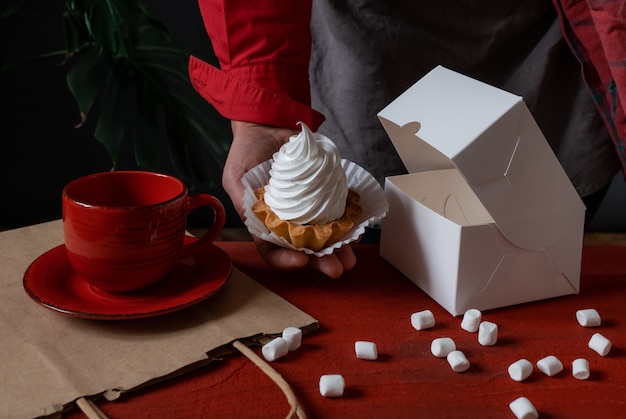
[0,221,317,417]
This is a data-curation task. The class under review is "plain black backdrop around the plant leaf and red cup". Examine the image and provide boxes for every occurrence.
[0,0,626,232]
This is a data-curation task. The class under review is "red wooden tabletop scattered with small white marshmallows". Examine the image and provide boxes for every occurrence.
[68,242,626,418]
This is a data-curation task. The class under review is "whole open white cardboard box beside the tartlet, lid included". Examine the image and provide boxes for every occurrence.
[378,66,585,315]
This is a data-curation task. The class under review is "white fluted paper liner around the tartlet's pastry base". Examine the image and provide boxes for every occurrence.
[241,159,388,256]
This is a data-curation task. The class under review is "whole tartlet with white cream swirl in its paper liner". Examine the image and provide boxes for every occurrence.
[242,123,387,254]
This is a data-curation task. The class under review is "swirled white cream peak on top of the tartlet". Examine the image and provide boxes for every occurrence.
[265,122,348,224]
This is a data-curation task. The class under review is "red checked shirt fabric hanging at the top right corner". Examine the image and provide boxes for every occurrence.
[553,0,626,170]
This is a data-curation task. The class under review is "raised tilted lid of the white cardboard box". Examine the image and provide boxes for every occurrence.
[378,66,584,249]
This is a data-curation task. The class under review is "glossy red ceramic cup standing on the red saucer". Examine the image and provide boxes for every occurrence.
[62,171,226,292]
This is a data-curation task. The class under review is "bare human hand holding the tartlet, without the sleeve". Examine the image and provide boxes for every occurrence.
[222,121,356,278]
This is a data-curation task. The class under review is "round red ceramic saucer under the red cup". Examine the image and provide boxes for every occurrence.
[24,241,232,320]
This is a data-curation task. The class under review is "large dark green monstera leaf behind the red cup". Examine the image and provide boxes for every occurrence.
[59,0,231,186]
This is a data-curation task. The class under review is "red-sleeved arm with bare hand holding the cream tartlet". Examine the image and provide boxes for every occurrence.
[189,0,356,277]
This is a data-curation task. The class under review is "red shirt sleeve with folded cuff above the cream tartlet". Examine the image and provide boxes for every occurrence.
[189,0,324,130]
